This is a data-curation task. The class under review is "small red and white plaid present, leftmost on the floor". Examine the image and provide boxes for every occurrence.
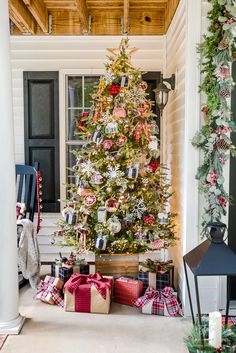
[36,276,64,308]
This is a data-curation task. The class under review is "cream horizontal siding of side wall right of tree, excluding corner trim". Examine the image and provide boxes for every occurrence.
[163,0,186,306]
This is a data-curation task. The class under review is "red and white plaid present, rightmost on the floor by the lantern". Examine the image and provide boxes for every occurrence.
[134,287,180,316]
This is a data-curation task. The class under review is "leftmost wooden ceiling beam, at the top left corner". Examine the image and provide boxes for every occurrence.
[9,0,36,34]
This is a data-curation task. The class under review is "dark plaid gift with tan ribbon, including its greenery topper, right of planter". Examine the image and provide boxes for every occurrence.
[138,259,174,291]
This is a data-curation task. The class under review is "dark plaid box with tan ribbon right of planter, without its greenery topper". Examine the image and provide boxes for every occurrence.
[138,268,174,291]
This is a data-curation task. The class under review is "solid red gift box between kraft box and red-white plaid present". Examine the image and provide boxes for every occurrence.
[115,277,143,306]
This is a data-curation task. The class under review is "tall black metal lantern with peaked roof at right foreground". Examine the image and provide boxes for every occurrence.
[183,222,236,326]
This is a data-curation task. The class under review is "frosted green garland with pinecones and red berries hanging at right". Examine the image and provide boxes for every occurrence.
[192,0,236,230]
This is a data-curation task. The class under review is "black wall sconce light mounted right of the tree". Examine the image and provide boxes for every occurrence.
[153,74,175,116]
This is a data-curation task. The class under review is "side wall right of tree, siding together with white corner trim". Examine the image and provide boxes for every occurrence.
[163,0,201,314]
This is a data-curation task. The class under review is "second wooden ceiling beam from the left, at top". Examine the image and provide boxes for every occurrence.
[23,0,48,33]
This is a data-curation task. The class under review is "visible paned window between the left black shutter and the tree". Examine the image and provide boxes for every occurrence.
[65,75,100,183]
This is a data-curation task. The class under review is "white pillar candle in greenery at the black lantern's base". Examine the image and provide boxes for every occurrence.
[209,311,222,348]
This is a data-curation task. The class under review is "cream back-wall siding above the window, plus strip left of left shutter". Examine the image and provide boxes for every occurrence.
[11,36,165,163]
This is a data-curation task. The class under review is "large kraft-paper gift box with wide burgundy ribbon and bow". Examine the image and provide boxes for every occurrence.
[64,273,113,314]
